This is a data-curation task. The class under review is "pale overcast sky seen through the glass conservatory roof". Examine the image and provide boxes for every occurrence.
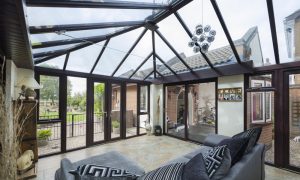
[27,0,300,93]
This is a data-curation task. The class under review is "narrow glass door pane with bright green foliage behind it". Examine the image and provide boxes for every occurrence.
[93,82,107,142]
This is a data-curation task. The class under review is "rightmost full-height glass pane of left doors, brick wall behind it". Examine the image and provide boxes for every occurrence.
[126,84,137,137]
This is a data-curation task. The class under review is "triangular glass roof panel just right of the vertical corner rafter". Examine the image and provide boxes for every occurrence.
[155,31,189,74]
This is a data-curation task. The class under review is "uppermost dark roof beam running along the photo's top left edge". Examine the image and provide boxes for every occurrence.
[26,0,170,9]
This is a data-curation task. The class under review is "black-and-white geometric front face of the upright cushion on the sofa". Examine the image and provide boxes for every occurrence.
[203,145,231,178]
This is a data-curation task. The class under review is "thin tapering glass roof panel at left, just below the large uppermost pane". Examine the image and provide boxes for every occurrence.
[30,26,127,43]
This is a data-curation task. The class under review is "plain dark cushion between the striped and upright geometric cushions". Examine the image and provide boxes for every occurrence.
[182,153,209,180]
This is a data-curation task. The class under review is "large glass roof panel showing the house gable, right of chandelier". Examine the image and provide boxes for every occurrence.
[217,0,275,66]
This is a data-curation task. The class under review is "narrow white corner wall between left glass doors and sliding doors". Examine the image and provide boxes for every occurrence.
[150,84,163,130]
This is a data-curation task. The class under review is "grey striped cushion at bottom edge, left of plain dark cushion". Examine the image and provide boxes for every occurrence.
[138,163,185,180]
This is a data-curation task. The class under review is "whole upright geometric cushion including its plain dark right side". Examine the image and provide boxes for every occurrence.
[203,145,231,180]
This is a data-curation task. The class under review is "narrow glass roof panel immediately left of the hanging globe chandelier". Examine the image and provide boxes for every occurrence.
[158,15,207,69]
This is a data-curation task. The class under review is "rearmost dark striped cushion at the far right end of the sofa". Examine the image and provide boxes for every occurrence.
[232,127,262,154]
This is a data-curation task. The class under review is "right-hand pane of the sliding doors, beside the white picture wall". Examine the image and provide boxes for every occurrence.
[188,82,216,142]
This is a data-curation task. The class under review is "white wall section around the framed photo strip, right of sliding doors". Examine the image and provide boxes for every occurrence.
[218,75,244,136]
